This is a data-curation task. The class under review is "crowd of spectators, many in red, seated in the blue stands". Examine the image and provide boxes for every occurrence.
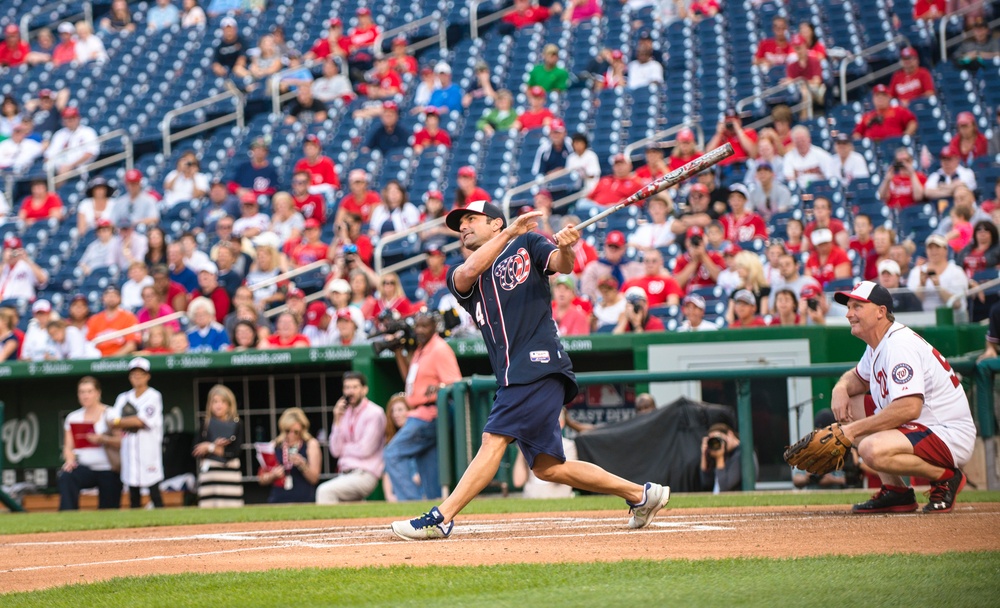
[0,0,1000,360]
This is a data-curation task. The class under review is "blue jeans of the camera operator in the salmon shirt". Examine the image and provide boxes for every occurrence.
[384,418,441,500]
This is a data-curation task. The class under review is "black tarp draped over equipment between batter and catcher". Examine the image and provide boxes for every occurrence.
[576,397,736,492]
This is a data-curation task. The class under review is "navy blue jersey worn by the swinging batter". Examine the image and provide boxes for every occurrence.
[448,232,576,394]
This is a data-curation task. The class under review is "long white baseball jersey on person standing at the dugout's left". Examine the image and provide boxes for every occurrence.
[112,388,163,488]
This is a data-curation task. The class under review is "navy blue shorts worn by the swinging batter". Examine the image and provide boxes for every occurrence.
[483,375,568,469]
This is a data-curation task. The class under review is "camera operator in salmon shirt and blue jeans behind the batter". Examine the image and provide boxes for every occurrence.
[385,311,462,500]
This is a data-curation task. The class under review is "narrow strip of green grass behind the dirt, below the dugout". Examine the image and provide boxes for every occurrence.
[0,491,1000,535]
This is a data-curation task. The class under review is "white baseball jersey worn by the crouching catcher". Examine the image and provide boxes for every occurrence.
[856,323,976,466]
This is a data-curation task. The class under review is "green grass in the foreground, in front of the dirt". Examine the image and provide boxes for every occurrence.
[0,547,1000,608]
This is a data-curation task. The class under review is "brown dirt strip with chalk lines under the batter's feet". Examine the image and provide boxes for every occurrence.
[0,503,1000,592]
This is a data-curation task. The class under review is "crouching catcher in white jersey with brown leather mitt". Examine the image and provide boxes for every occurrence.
[785,281,976,513]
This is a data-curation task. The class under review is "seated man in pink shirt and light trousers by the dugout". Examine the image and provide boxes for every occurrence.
[316,372,385,505]
